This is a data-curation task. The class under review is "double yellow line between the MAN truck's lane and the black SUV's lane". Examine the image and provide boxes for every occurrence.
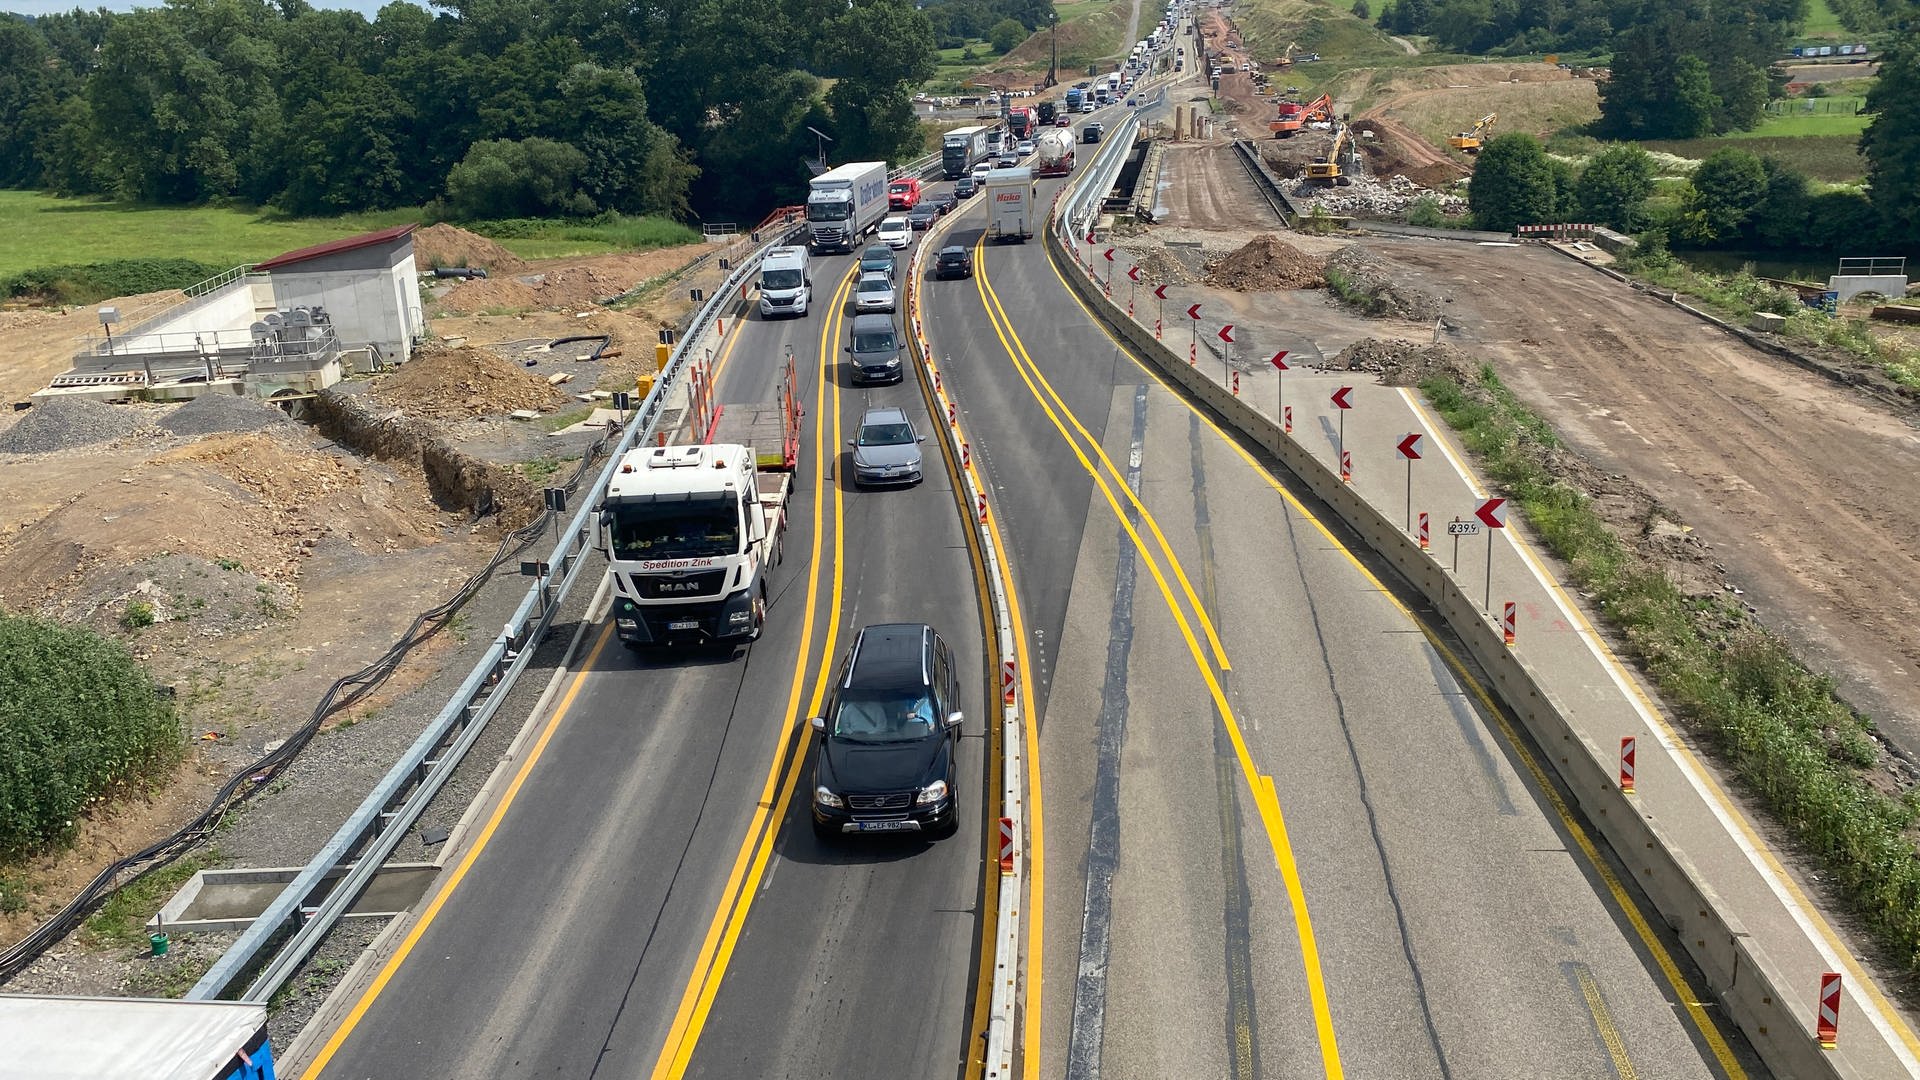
[653,269,852,1080]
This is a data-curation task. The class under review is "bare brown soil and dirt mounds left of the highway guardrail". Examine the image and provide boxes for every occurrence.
[0,227,724,949]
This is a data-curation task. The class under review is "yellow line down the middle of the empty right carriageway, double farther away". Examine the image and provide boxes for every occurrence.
[973,231,1346,1080]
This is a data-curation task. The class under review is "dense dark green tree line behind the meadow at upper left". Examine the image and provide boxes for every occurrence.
[0,0,936,219]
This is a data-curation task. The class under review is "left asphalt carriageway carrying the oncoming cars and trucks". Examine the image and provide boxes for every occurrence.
[305,244,989,1078]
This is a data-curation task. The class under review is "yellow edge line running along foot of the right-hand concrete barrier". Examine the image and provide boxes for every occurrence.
[1048,239,1747,1080]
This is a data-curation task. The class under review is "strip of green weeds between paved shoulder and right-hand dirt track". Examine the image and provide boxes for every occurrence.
[1421,367,1920,972]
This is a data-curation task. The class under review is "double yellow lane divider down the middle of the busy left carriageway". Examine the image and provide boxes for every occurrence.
[653,267,852,1080]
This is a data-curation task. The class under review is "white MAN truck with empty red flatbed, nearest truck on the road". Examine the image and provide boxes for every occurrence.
[595,350,801,650]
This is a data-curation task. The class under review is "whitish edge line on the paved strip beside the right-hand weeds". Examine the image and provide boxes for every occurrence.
[1400,388,1920,1057]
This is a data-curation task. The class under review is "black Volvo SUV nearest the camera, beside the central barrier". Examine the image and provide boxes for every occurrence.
[814,623,960,840]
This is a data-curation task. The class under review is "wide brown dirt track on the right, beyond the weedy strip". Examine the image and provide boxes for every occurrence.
[1367,240,1920,755]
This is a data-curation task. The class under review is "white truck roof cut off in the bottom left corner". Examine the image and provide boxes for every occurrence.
[0,994,267,1080]
